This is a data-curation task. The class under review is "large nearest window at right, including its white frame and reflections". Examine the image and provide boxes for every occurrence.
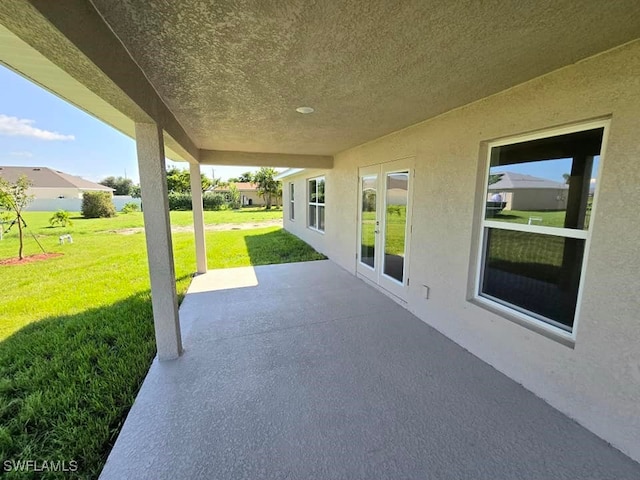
[477,125,604,334]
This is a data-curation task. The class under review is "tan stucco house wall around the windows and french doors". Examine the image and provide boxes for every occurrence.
[283,41,640,460]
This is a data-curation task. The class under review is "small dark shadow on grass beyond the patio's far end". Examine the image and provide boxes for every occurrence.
[244,228,327,266]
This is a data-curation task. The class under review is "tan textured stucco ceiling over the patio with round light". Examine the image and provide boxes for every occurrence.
[63,0,640,155]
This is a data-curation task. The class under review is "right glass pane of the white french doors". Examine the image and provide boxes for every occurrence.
[384,172,409,282]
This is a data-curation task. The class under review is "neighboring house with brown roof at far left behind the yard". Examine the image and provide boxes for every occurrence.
[0,166,113,211]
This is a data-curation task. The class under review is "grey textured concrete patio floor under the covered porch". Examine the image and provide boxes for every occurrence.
[100,260,640,480]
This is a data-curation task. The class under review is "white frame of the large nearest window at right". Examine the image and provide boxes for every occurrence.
[471,119,610,347]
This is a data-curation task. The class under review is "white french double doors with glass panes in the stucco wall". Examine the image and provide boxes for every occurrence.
[356,160,413,299]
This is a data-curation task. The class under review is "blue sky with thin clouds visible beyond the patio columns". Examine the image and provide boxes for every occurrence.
[0,65,255,183]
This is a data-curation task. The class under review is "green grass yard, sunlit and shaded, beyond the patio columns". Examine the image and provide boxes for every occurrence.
[0,209,324,479]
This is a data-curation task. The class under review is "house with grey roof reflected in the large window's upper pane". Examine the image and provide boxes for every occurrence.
[487,172,569,211]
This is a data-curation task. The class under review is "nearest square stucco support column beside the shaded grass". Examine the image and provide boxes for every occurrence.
[136,123,182,360]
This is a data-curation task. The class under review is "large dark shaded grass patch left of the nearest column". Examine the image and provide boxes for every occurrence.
[0,292,161,479]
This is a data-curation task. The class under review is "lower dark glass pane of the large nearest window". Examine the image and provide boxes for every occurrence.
[480,228,585,331]
